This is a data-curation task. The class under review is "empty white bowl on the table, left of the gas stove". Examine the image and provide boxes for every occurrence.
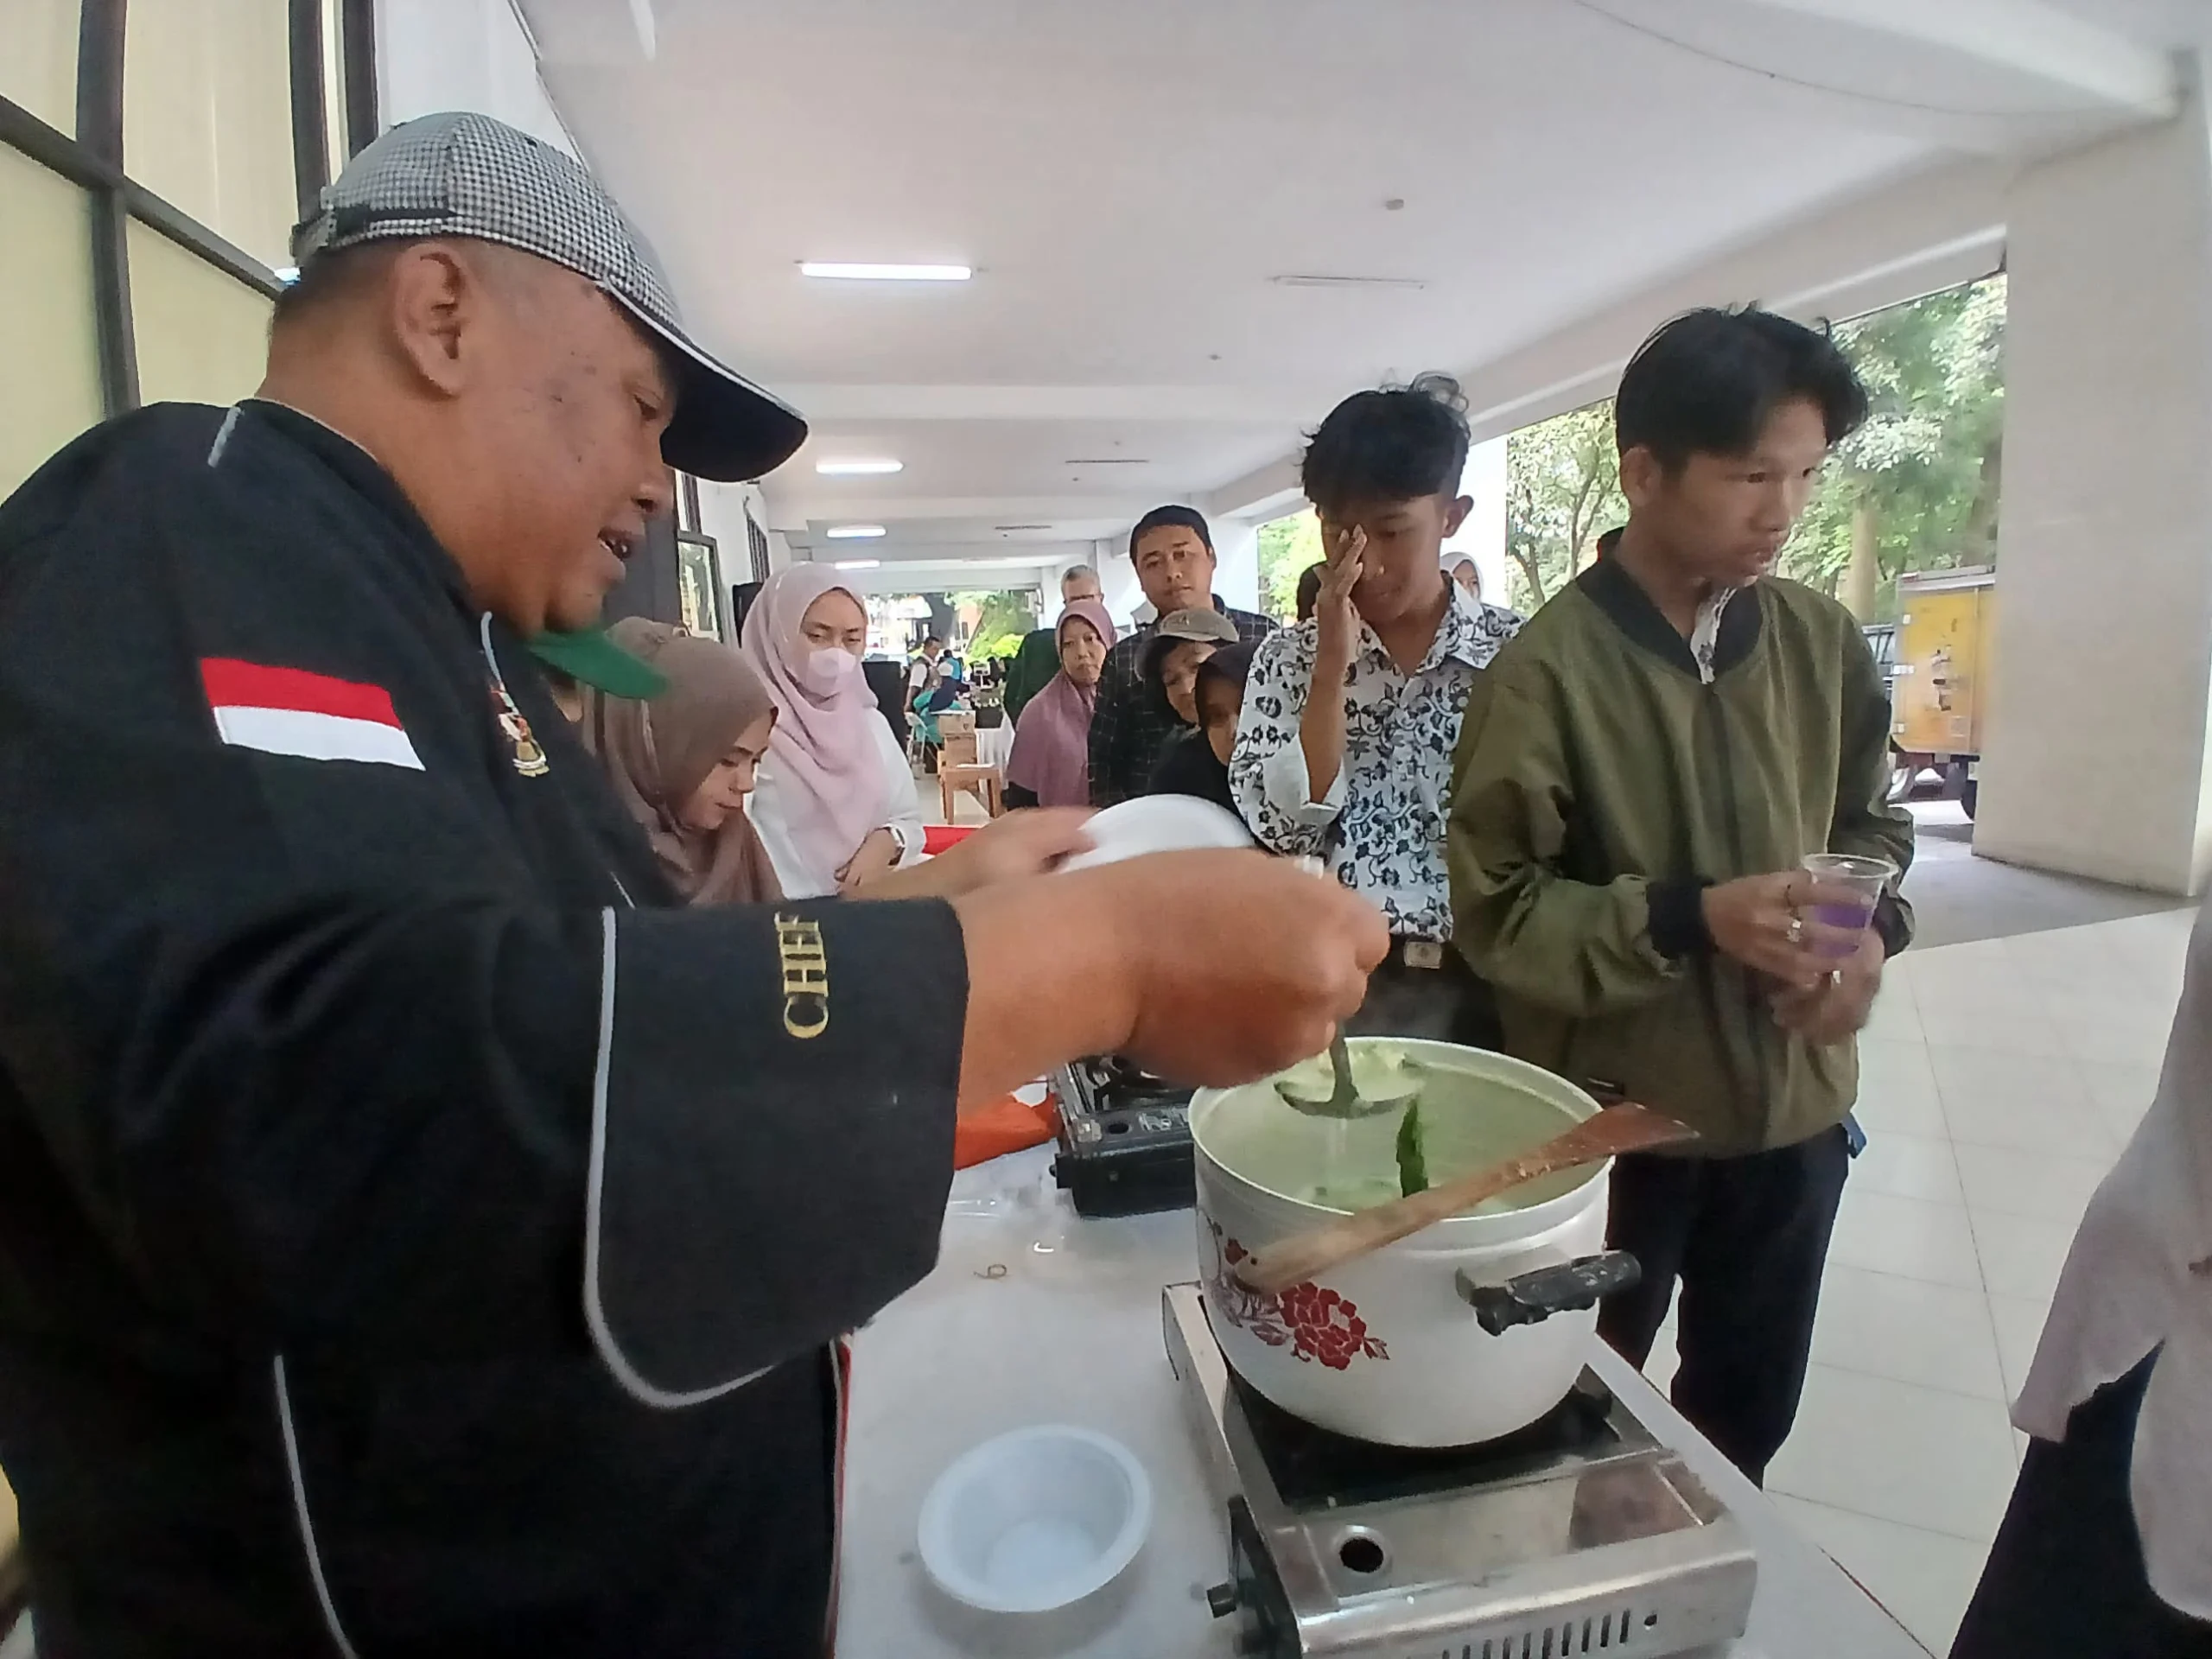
[920,1422,1153,1612]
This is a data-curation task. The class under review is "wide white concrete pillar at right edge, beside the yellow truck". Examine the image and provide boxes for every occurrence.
[1975,53,2212,893]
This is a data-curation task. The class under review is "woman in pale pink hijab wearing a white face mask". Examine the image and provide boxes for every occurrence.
[743,564,923,898]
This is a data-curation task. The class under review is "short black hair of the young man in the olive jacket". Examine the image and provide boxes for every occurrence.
[1612,305,1867,474]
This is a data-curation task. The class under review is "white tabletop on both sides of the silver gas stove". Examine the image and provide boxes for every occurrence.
[838,1146,1924,1659]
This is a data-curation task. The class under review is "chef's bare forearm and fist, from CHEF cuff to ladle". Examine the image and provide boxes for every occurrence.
[953,852,1389,1103]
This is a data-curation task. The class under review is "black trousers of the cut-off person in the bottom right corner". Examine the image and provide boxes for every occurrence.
[1951,1360,2212,1659]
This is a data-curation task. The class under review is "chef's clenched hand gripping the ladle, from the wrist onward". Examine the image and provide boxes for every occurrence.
[1089,852,1389,1086]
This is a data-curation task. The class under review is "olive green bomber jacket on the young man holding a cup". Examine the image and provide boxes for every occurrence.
[1446,560,1913,1154]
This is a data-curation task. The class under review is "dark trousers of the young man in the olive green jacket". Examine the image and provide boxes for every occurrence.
[1597,1126,1852,1482]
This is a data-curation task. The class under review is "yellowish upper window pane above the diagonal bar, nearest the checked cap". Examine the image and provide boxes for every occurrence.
[124,0,299,270]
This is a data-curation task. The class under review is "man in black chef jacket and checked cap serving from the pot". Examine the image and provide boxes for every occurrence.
[0,115,1382,1659]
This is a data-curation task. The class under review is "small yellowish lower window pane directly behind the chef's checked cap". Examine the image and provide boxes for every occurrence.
[130,219,272,413]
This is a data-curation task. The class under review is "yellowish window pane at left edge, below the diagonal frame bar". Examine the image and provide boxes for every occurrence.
[0,143,102,495]
